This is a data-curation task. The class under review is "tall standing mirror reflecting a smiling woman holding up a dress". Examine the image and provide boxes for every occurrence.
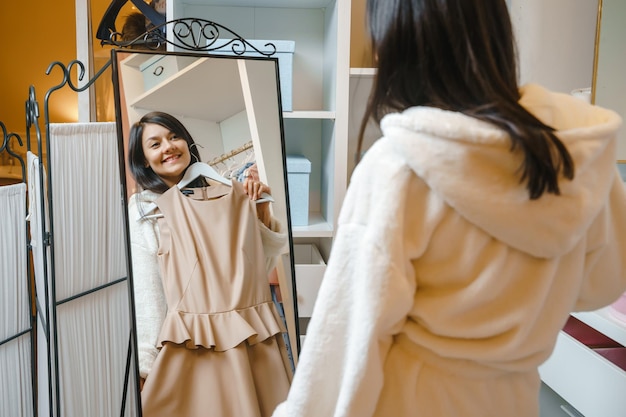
[112,50,299,415]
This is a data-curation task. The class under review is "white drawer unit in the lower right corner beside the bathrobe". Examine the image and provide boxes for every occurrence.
[539,308,626,417]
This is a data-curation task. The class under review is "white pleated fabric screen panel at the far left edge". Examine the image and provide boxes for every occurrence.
[0,183,34,417]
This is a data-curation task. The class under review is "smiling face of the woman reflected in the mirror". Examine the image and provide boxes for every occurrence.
[141,123,191,187]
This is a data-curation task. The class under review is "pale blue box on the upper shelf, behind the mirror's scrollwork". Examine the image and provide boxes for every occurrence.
[211,39,296,111]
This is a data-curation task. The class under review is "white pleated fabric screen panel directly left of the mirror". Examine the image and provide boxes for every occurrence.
[31,123,135,417]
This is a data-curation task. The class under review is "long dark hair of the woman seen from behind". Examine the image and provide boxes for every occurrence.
[358,0,574,199]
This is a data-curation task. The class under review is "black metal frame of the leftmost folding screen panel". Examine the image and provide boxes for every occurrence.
[0,121,37,415]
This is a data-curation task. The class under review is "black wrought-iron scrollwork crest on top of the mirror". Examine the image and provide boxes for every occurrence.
[102,18,276,56]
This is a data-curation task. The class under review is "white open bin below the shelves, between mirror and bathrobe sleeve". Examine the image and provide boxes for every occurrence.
[293,244,326,317]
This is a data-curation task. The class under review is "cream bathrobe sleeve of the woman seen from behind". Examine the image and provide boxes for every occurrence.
[274,144,432,417]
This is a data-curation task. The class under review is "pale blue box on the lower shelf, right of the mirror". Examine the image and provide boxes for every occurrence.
[287,155,311,226]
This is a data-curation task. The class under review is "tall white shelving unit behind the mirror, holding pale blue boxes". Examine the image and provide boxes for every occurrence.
[167,0,350,247]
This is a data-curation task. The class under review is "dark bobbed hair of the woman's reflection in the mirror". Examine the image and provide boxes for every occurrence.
[128,111,200,193]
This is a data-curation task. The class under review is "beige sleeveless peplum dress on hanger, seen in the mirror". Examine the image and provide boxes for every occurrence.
[141,181,291,417]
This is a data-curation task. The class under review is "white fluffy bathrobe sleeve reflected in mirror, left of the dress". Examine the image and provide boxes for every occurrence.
[128,195,167,378]
